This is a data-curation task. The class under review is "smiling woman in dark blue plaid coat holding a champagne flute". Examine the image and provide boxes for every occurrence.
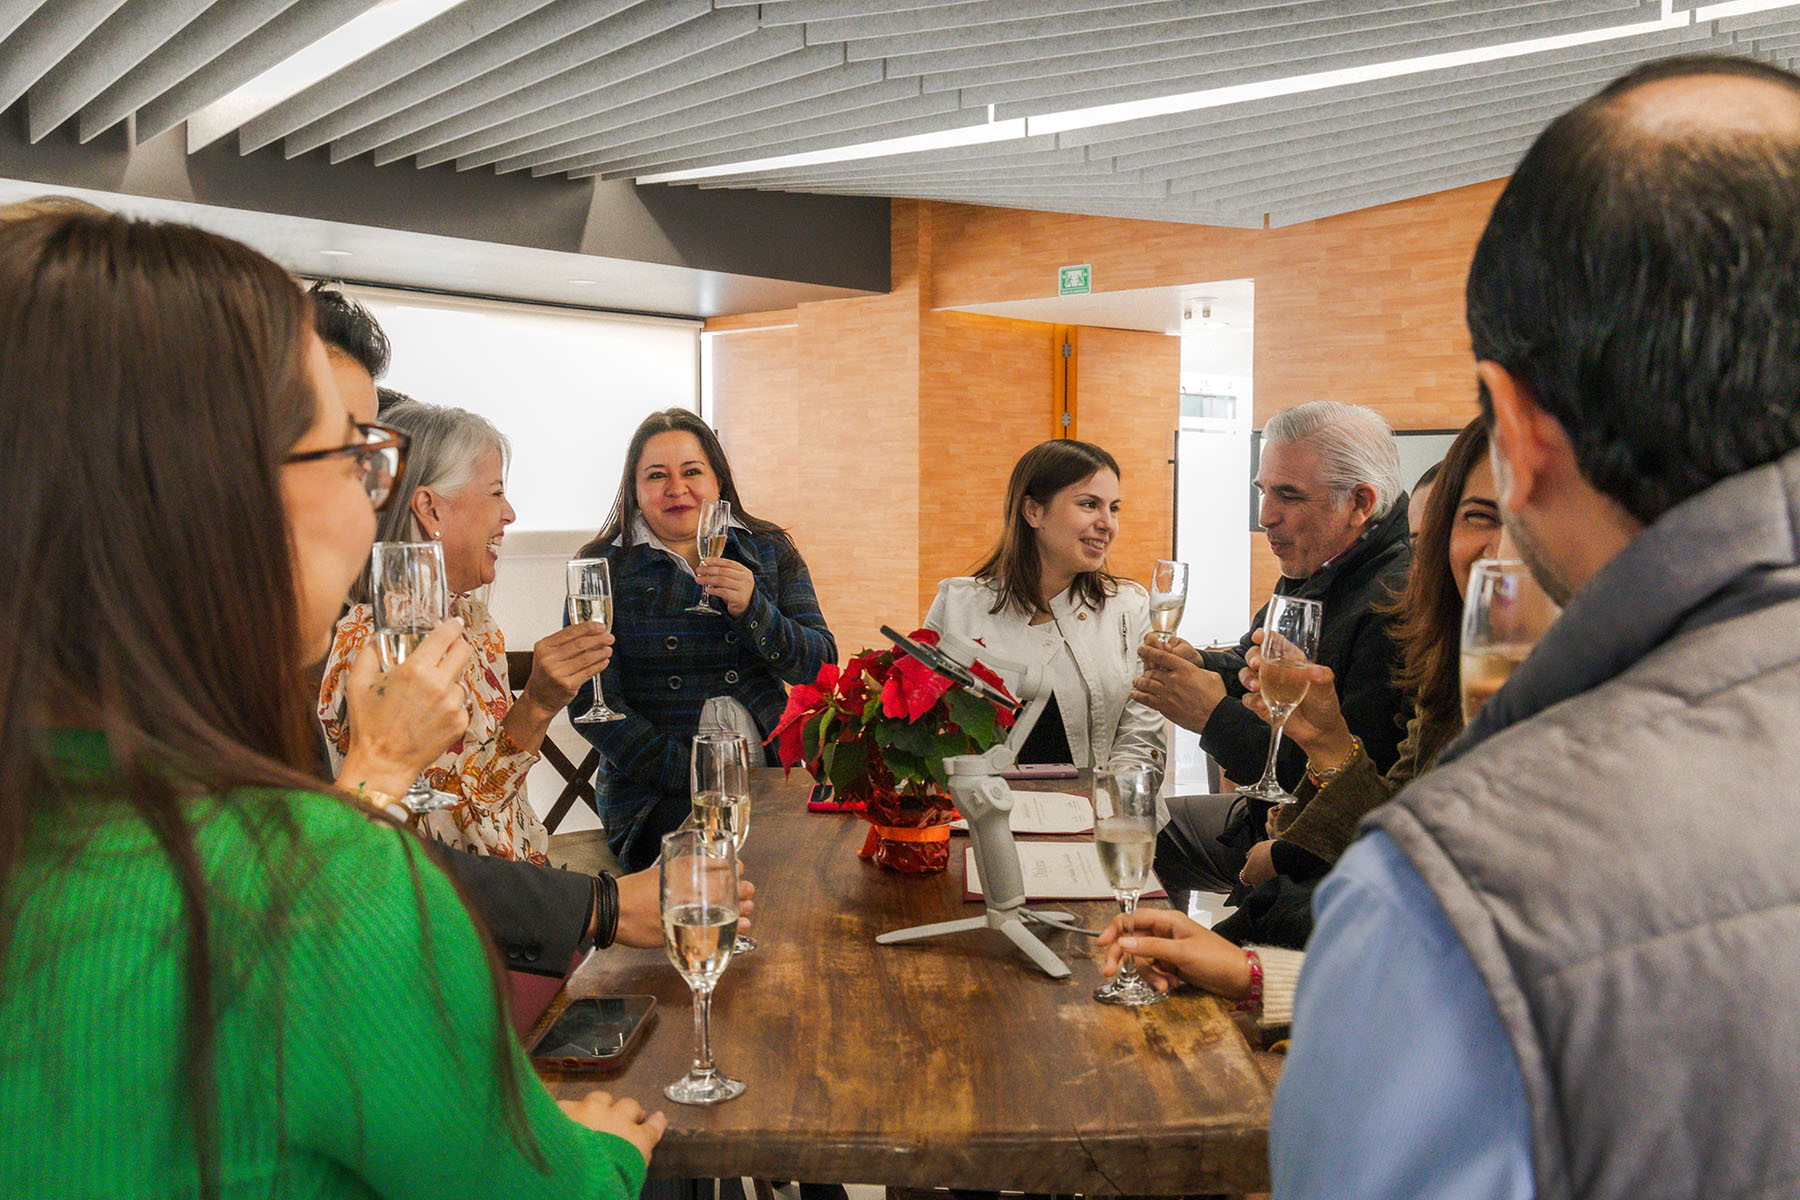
[571,408,837,871]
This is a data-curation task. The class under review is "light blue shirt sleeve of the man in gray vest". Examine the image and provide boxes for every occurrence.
[1269,833,1535,1200]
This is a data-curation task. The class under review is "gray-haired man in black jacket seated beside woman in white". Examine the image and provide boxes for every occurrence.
[1132,399,1411,945]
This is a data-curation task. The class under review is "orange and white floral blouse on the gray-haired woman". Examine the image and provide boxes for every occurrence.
[319,596,551,864]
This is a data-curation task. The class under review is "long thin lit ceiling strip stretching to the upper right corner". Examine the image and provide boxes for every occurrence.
[637,0,1800,184]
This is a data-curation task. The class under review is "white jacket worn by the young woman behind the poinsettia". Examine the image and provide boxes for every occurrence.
[925,576,1163,770]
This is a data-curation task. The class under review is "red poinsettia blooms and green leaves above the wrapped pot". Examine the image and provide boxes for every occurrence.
[770,630,1013,801]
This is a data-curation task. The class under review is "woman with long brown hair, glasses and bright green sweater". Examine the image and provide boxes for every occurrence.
[0,212,664,1200]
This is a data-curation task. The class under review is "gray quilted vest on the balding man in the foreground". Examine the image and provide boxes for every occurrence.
[1364,453,1800,1200]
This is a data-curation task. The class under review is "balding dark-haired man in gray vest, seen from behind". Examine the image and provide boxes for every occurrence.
[1271,58,1800,1200]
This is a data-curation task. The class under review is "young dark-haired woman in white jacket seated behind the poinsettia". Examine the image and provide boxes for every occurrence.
[925,439,1163,770]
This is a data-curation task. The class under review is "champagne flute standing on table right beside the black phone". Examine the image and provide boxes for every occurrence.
[659,829,743,1105]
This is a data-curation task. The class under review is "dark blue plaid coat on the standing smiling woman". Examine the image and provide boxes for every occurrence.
[571,529,837,871]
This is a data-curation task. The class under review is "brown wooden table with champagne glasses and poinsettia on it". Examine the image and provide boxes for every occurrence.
[549,770,1269,1195]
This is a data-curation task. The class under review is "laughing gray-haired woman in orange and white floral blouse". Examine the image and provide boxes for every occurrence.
[319,401,612,864]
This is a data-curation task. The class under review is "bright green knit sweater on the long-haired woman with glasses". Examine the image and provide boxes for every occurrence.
[0,737,644,1200]
